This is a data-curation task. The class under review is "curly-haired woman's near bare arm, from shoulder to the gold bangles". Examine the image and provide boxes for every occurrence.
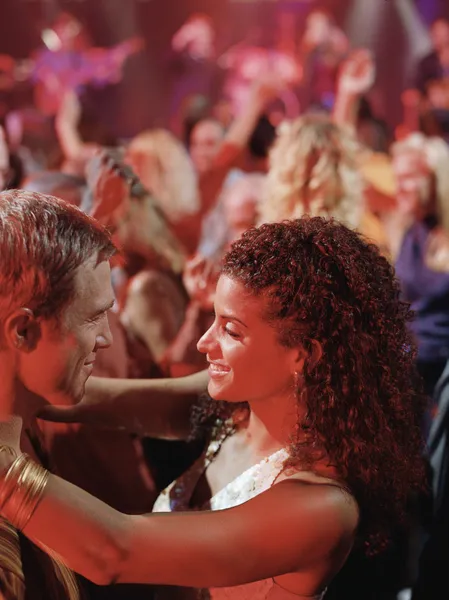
[11,476,357,588]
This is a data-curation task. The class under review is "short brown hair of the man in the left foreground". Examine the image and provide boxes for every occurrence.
[0,190,116,320]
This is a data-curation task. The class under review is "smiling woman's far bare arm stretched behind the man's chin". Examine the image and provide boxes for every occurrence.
[38,371,209,440]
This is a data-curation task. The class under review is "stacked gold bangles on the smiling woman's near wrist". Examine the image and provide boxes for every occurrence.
[0,454,50,531]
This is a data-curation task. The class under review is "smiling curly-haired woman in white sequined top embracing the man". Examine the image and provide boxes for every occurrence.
[0,217,423,600]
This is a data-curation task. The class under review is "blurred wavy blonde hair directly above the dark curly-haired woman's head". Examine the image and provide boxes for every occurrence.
[260,115,388,252]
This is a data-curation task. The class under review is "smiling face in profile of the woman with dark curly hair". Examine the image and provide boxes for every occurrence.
[198,275,302,403]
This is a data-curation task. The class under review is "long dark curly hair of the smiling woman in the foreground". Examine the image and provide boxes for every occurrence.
[191,217,426,551]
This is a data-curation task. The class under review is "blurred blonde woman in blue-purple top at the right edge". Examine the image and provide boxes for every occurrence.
[385,133,449,396]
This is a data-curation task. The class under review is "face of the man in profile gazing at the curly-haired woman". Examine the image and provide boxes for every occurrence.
[19,256,114,404]
